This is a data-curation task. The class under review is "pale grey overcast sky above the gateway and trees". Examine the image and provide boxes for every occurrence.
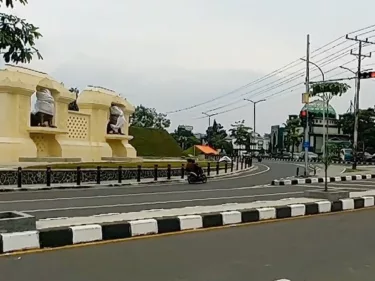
[5,0,375,133]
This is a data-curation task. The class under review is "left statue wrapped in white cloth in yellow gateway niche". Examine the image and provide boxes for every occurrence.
[30,89,56,128]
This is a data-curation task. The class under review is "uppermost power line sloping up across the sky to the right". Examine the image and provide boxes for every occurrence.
[166,25,375,114]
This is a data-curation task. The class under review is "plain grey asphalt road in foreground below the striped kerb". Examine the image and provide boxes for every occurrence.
[0,209,375,281]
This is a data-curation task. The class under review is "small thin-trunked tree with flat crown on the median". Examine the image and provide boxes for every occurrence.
[311,82,350,191]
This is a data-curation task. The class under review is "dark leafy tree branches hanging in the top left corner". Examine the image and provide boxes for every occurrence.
[0,0,43,64]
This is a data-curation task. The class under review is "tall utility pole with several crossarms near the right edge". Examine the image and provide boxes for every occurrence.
[346,34,375,169]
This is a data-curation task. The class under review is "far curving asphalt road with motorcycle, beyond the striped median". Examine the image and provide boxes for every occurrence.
[0,162,303,219]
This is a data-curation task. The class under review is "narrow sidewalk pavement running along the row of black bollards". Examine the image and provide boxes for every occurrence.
[0,165,258,192]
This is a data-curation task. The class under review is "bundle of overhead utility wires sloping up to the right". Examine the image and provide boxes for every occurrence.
[166,24,375,119]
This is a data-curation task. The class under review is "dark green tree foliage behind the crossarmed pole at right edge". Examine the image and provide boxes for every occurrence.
[339,108,375,153]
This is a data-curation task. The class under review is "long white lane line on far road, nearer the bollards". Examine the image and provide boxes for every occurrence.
[0,185,274,204]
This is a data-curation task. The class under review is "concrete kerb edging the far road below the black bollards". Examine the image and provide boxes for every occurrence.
[0,165,258,192]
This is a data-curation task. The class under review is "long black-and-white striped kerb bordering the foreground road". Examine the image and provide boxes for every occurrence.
[0,196,374,254]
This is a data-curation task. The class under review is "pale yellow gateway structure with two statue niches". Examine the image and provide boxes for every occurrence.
[0,65,137,163]
